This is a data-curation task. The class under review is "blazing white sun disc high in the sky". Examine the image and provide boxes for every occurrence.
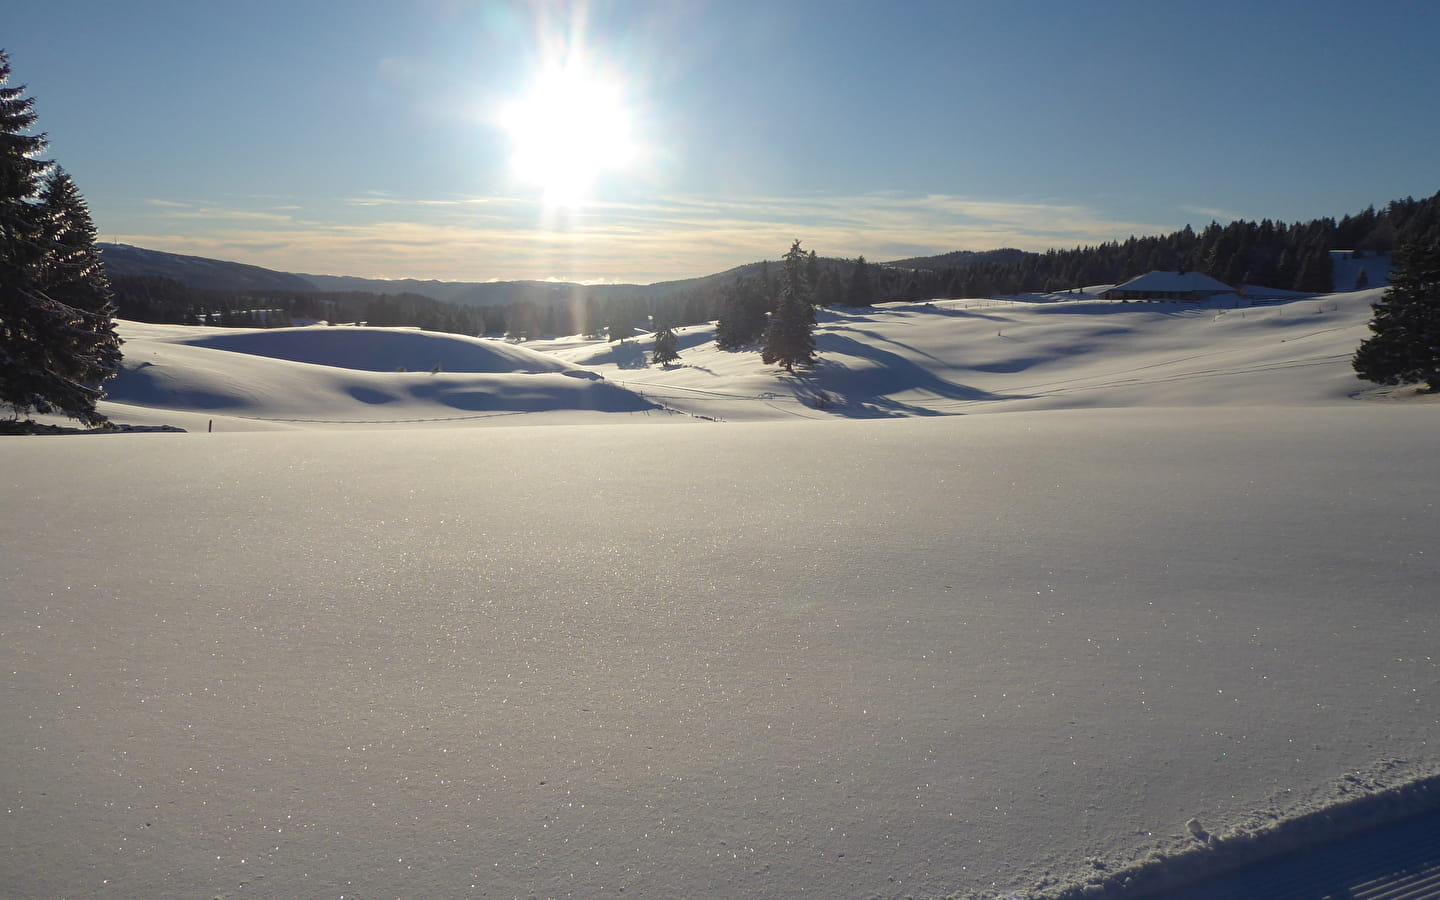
[501,65,638,206]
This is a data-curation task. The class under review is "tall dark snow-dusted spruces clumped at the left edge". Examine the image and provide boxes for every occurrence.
[0,50,120,425]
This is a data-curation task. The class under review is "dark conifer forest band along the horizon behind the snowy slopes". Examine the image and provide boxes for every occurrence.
[111,193,1440,338]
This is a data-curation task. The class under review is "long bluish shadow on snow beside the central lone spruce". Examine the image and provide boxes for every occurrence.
[808,333,1027,418]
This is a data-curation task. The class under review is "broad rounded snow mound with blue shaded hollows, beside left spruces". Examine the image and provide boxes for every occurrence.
[104,323,655,431]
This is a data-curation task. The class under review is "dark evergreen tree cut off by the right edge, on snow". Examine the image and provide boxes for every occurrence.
[1352,237,1440,390]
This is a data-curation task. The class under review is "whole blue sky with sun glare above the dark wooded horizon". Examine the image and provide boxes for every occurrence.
[0,0,1440,282]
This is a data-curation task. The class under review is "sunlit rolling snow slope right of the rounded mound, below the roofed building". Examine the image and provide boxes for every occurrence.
[554,289,1380,420]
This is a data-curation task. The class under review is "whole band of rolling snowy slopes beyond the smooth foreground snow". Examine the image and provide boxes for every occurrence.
[104,288,1405,431]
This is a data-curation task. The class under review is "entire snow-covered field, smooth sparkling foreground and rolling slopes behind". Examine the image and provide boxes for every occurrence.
[0,291,1440,897]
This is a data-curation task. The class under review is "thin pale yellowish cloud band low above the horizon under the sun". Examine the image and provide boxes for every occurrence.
[124,192,1171,284]
